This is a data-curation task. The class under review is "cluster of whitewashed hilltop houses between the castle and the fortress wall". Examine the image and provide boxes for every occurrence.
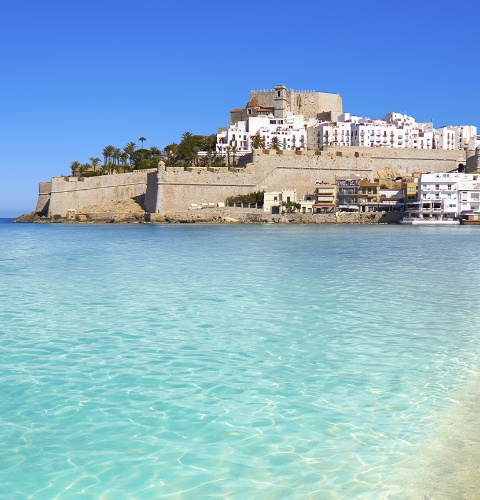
[217,107,480,156]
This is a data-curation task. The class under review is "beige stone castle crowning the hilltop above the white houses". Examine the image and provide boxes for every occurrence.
[230,85,343,124]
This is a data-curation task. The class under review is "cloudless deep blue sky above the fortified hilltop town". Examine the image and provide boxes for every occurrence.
[0,0,480,217]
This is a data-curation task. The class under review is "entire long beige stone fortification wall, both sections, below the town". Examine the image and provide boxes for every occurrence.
[36,147,466,218]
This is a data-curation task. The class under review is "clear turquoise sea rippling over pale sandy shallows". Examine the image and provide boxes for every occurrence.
[0,221,480,500]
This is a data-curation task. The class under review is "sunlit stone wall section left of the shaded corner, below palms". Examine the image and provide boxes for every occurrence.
[48,170,155,216]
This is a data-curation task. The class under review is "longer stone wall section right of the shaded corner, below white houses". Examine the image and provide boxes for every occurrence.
[155,147,466,214]
